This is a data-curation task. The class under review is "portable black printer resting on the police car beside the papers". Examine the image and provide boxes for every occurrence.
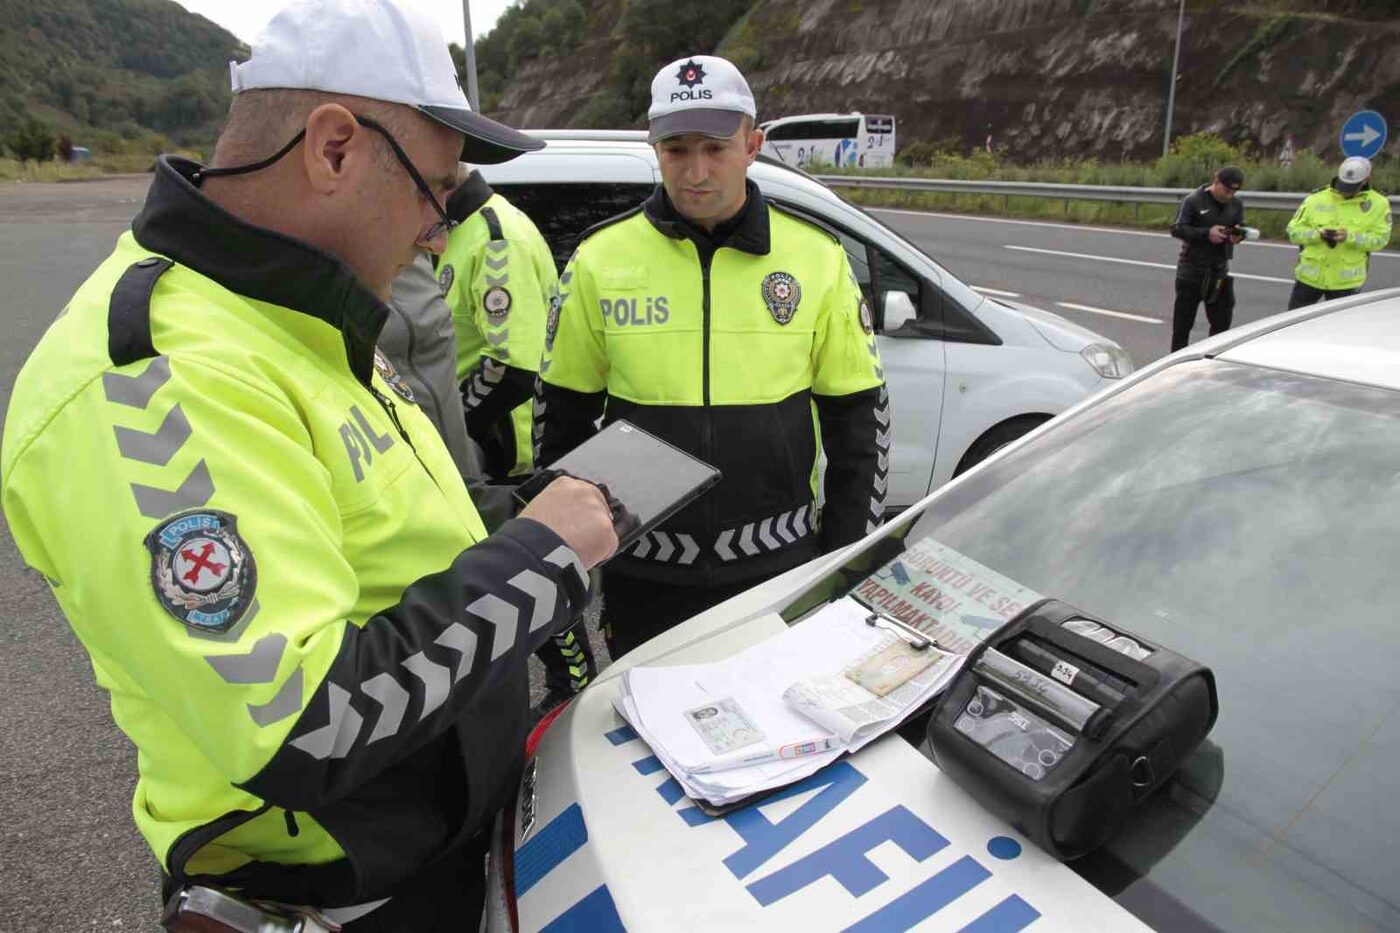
[928,600,1219,859]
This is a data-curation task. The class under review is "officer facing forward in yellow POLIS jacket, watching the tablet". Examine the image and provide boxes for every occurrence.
[535,56,890,658]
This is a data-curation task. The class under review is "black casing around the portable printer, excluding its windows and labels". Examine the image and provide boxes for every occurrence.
[928,600,1219,860]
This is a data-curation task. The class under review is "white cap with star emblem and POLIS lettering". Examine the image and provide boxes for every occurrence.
[647,55,757,143]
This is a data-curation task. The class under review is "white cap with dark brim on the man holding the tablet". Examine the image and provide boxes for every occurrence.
[228,0,545,164]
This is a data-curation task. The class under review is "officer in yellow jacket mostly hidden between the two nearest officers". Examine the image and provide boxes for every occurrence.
[437,171,598,713]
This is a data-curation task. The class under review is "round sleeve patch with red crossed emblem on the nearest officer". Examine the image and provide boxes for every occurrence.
[146,509,258,632]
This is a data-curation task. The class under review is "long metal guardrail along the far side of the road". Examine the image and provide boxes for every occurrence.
[813,175,1400,210]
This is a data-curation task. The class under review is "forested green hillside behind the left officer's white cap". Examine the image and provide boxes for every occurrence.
[0,0,246,153]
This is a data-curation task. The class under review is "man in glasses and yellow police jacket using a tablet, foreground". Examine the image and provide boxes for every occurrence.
[0,0,616,933]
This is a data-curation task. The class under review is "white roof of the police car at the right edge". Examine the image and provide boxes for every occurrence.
[1217,289,1400,389]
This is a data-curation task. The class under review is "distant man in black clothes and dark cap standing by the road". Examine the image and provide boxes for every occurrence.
[1172,165,1245,352]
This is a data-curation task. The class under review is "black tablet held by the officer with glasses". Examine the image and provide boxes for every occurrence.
[526,420,721,553]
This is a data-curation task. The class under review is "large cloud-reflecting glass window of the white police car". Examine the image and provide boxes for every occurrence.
[789,360,1400,930]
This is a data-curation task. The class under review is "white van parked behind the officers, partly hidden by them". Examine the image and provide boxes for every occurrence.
[480,130,1133,510]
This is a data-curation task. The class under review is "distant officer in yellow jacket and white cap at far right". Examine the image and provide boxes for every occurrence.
[1288,156,1390,311]
